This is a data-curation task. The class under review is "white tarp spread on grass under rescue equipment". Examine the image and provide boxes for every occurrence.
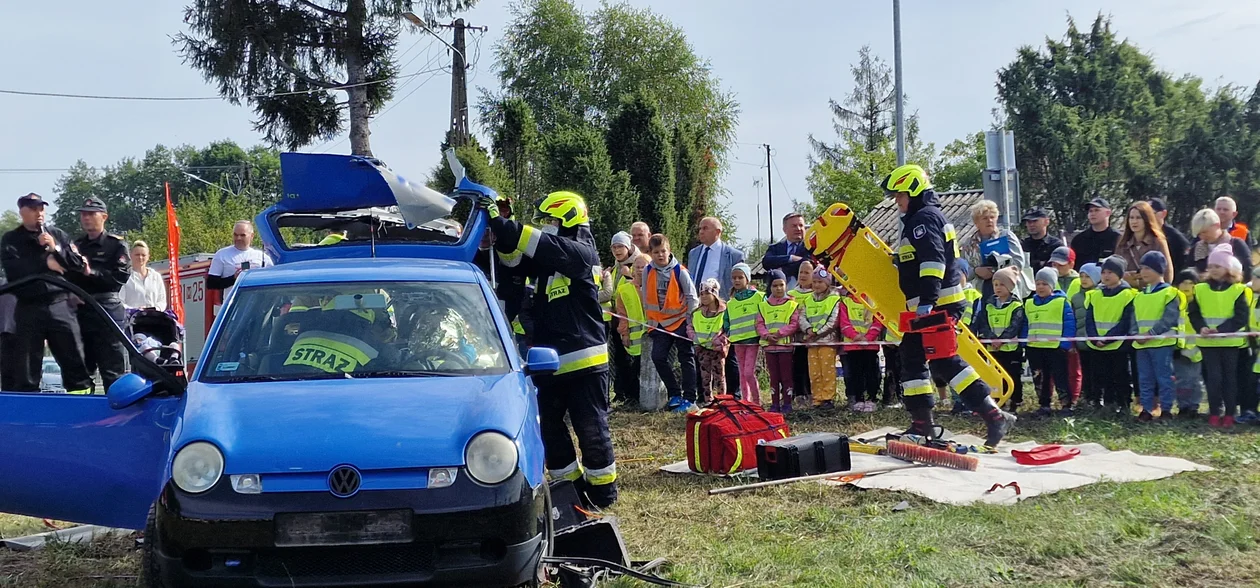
[660,427,1212,505]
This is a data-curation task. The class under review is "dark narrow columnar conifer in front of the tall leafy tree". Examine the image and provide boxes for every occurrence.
[606,92,687,247]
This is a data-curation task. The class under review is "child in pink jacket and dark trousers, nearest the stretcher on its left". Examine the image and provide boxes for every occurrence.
[839,288,883,413]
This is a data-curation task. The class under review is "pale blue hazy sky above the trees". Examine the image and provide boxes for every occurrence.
[0,0,1260,242]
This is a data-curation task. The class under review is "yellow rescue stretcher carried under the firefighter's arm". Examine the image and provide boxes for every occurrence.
[805,203,1016,405]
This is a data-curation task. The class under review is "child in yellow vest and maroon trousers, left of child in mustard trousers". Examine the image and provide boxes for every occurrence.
[757,269,800,413]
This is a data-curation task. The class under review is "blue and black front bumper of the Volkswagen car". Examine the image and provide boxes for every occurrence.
[146,472,543,587]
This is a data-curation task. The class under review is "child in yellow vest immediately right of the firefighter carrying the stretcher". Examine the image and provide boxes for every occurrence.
[972,267,1024,414]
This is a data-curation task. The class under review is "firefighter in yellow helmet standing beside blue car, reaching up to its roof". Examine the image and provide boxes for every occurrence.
[481,191,617,507]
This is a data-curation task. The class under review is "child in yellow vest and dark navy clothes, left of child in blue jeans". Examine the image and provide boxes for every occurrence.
[1085,256,1138,416]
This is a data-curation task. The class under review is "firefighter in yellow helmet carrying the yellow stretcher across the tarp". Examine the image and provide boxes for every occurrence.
[882,165,1016,447]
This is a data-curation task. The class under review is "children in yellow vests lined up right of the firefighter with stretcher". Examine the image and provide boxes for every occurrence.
[971,246,1260,428]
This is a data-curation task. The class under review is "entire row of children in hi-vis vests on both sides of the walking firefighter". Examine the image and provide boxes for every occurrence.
[619,234,1260,428]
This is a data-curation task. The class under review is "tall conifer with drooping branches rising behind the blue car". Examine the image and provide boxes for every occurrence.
[175,0,476,155]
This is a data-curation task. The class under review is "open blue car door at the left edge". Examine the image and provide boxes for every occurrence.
[0,392,184,529]
